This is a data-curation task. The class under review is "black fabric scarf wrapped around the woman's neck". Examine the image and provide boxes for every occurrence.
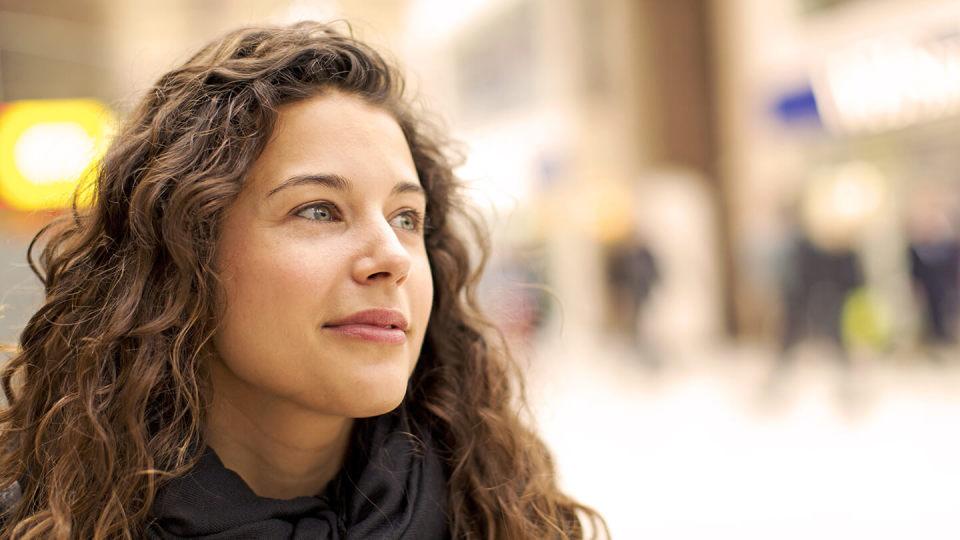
[148,406,449,540]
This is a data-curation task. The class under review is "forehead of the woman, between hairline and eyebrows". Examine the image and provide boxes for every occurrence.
[244,91,419,189]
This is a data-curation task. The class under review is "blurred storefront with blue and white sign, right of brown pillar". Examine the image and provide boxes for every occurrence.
[714,0,960,352]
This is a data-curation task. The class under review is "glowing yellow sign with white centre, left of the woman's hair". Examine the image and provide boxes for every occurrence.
[0,99,114,210]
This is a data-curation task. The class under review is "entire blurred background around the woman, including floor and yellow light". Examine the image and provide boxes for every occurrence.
[0,0,960,539]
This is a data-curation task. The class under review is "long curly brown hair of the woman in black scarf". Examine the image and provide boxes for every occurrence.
[0,22,606,538]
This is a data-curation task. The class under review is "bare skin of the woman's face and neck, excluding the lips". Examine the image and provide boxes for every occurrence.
[206,91,433,499]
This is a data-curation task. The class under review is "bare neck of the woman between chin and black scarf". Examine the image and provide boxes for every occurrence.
[204,361,353,499]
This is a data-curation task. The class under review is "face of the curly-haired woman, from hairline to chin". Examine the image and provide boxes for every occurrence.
[214,92,433,418]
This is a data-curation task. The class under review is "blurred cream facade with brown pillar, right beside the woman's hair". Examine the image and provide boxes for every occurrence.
[394,0,732,356]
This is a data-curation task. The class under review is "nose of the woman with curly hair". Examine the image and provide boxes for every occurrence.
[353,216,410,285]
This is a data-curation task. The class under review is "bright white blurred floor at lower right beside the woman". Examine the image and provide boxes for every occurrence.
[526,339,960,540]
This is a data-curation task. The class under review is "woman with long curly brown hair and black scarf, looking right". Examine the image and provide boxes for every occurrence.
[0,23,603,538]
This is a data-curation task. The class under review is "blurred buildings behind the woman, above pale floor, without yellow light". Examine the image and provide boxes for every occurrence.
[0,0,960,354]
